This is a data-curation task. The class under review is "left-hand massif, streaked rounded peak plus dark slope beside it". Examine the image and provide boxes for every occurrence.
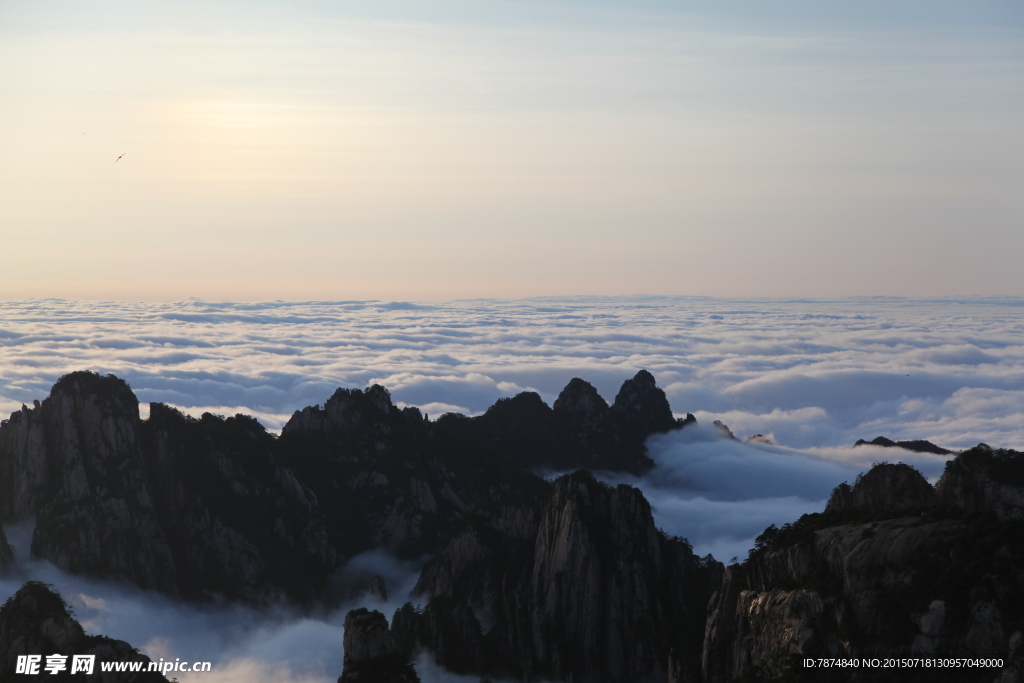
[0,373,336,602]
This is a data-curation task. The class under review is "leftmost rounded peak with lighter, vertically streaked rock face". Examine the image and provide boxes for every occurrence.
[0,373,177,593]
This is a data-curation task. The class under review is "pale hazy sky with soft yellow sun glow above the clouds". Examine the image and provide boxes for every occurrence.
[0,0,1024,301]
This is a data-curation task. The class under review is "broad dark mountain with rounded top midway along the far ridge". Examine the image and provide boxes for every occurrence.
[279,386,547,558]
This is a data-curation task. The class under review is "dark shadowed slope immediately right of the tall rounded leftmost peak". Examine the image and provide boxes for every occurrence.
[141,403,340,602]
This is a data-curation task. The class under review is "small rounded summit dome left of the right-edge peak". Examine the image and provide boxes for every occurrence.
[825,463,935,512]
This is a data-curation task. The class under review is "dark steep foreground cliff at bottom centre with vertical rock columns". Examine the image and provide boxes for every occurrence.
[391,471,722,683]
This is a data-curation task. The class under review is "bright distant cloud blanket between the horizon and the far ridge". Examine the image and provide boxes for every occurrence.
[0,297,1024,449]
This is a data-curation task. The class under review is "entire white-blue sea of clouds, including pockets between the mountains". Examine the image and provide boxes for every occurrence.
[0,297,1024,683]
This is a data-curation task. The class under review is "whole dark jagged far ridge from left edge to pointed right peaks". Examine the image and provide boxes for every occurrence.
[0,371,683,603]
